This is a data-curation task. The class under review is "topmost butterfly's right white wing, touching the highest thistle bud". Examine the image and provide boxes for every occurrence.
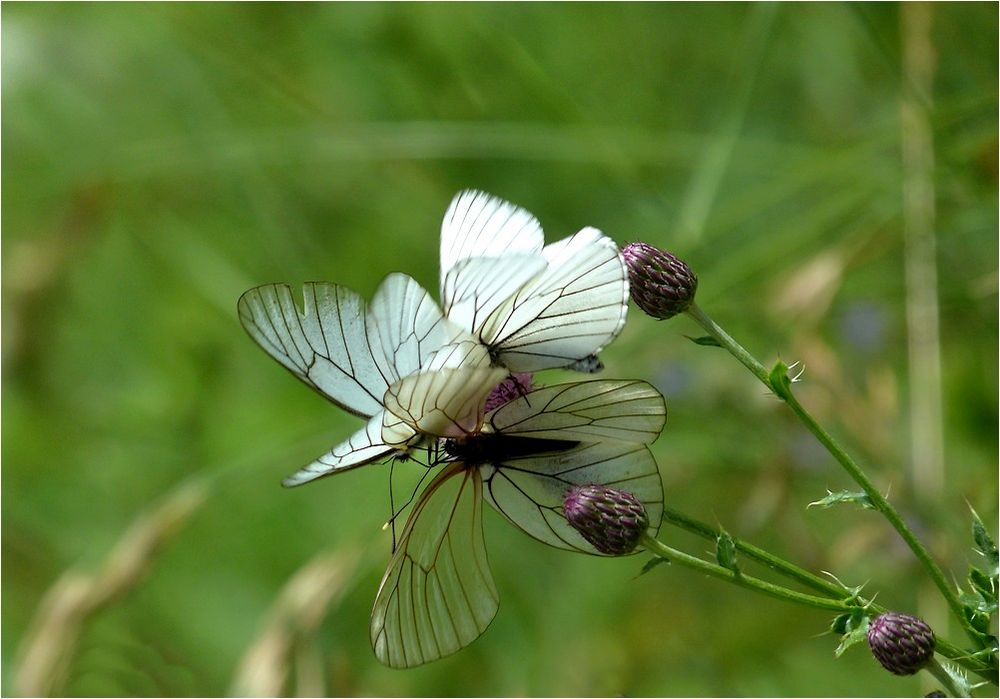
[476,228,628,372]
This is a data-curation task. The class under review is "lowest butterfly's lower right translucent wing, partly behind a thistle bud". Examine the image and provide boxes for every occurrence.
[480,442,663,555]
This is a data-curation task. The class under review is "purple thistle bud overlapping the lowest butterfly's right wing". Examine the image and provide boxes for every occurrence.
[563,484,649,556]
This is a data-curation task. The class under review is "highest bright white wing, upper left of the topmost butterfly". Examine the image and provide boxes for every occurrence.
[441,189,544,286]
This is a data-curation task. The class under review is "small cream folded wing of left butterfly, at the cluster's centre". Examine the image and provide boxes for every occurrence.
[382,367,507,446]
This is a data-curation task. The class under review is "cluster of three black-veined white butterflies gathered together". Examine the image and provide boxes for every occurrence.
[238,190,666,667]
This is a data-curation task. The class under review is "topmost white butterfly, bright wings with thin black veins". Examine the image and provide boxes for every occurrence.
[441,190,628,372]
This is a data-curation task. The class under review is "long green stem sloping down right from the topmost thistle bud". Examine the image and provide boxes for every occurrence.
[687,304,983,648]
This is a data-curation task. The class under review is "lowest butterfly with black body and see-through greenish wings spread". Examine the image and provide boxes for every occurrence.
[371,369,666,668]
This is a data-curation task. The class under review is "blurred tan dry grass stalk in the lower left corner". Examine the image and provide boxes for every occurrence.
[14,481,207,696]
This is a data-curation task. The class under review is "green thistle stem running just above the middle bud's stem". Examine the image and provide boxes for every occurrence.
[663,507,997,684]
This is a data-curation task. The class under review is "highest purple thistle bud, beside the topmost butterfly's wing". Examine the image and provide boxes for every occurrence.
[622,243,698,320]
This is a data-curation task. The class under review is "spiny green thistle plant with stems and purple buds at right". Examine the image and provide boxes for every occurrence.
[620,243,1000,696]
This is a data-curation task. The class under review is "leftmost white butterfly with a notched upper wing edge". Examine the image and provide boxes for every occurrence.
[237,273,505,486]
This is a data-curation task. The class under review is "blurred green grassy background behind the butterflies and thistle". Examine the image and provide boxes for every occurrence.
[2,3,998,696]
